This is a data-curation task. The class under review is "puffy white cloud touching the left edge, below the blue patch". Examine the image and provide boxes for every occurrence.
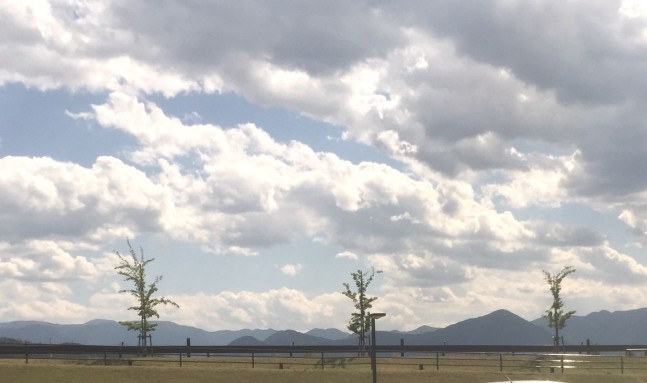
[0,157,167,241]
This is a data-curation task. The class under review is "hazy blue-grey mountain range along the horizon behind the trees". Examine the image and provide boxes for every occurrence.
[0,308,647,346]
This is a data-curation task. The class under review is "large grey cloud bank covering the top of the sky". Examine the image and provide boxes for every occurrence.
[3,2,644,201]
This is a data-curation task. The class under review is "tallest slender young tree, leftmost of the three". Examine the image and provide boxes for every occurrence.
[115,240,180,351]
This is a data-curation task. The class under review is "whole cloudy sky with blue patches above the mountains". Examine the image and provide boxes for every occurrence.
[0,0,647,331]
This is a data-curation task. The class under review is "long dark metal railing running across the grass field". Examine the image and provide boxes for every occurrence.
[0,344,647,374]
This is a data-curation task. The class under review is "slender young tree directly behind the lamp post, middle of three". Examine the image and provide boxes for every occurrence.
[342,267,377,351]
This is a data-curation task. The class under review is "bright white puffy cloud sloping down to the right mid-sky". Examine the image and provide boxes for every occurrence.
[87,94,556,253]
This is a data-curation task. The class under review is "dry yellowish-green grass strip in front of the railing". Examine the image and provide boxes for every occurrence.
[0,360,647,383]
